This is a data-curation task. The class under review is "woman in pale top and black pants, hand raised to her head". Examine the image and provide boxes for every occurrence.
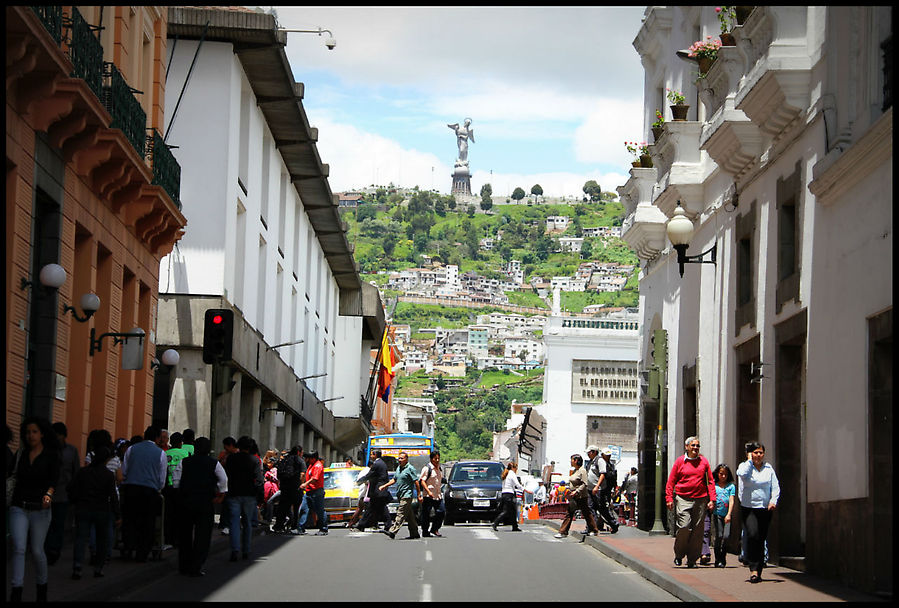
[737,441,780,583]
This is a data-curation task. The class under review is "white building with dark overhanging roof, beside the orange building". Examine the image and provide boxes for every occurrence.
[156,7,384,462]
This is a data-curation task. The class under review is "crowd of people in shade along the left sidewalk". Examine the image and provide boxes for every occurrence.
[6,416,344,602]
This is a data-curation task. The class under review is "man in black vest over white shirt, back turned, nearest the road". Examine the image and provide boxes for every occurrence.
[172,437,228,576]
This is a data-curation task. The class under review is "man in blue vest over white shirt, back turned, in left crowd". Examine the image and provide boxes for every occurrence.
[120,425,168,562]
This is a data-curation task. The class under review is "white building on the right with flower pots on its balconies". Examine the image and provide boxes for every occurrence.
[619,6,893,594]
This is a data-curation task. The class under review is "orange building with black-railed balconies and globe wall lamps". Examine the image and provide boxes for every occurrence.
[6,6,186,455]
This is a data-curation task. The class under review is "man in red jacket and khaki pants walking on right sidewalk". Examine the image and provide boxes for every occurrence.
[665,437,715,568]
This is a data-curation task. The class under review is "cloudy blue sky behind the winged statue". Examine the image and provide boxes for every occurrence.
[262,6,644,196]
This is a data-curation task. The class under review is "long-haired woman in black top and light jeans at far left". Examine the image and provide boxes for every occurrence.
[9,416,60,602]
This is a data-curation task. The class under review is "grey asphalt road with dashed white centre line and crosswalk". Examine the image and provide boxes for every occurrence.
[109,522,678,602]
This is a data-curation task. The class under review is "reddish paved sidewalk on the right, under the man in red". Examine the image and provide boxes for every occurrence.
[526,519,885,602]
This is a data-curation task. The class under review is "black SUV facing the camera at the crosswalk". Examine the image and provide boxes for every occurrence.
[443,460,504,526]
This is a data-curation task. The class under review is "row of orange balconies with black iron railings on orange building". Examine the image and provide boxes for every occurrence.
[6,6,187,256]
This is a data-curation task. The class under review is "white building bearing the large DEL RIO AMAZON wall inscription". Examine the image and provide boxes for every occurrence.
[536,292,640,470]
